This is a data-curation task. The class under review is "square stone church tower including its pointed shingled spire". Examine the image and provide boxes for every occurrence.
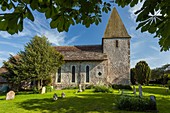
[102,8,130,84]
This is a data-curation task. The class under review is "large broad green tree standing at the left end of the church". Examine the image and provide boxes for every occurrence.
[4,36,64,89]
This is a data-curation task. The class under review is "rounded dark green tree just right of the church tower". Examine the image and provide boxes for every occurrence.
[135,61,151,85]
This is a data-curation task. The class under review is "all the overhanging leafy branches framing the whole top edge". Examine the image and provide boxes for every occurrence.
[0,0,170,51]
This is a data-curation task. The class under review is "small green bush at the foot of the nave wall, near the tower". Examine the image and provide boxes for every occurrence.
[94,86,113,93]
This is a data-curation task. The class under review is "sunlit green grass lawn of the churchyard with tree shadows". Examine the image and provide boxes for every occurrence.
[0,86,170,113]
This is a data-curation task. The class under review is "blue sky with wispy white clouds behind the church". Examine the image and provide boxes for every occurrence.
[0,3,170,69]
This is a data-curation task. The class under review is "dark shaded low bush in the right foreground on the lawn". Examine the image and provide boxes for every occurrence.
[115,96,156,111]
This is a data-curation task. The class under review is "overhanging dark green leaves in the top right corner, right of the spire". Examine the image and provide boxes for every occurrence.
[115,0,170,51]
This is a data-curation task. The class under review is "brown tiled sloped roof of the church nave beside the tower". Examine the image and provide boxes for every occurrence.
[55,45,107,61]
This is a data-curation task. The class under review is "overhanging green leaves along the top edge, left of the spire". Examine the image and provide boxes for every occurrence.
[0,0,111,34]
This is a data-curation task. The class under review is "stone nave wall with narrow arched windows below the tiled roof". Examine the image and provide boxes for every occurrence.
[54,60,107,88]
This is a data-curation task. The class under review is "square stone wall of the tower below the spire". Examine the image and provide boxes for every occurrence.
[103,38,130,84]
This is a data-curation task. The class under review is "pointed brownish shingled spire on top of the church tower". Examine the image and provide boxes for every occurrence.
[103,8,130,38]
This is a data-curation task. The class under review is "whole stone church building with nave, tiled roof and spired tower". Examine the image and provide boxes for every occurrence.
[54,8,130,88]
